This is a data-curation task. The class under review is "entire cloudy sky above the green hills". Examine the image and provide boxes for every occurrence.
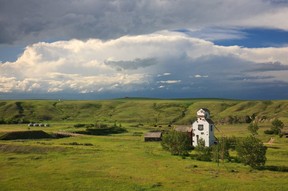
[0,0,288,100]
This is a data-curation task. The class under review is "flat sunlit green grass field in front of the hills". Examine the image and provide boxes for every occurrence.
[0,124,288,191]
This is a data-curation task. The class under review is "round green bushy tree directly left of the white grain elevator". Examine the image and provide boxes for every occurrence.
[161,130,192,156]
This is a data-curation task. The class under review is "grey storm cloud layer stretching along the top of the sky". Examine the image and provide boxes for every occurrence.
[0,0,286,43]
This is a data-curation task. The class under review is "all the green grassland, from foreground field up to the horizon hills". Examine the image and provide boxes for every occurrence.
[0,99,288,191]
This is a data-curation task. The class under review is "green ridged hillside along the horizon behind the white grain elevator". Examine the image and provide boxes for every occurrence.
[0,98,288,124]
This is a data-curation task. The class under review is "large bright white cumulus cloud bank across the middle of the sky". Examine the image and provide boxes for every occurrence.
[0,31,288,97]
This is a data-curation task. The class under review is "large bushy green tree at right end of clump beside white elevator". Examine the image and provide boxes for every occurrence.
[236,136,267,168]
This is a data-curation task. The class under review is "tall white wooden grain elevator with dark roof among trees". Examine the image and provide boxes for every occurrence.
[192,108,216,147]
